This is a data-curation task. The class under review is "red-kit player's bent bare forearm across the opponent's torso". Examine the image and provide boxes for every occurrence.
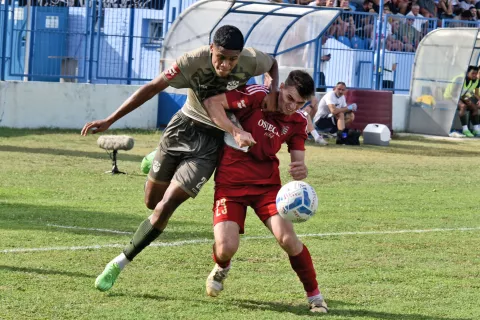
[203,93,256,148]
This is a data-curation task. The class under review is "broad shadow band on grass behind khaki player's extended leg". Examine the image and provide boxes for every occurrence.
[0,203,213,240]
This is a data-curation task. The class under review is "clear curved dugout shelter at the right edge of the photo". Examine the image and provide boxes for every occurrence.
[407,28,480,136]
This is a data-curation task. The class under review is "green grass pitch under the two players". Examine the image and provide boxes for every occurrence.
[0,128,480,320]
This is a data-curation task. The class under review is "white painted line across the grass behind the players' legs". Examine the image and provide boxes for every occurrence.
[0,225,480,253]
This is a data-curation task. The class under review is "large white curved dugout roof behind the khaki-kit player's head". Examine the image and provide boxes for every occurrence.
[162,0,341,82]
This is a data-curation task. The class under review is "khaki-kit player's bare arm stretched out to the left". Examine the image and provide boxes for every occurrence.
[81,73,169,136]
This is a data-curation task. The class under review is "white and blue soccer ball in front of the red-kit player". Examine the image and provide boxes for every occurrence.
[276,181,318,222]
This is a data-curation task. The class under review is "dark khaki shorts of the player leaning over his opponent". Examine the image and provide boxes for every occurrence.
[148,111,224,198]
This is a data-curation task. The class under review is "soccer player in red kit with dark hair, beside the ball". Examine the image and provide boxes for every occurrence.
[204,70,328,313]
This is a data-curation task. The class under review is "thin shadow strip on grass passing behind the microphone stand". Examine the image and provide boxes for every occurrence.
[0,146,143,163]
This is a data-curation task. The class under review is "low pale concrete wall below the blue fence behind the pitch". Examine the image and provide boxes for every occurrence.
[0,81,408,131]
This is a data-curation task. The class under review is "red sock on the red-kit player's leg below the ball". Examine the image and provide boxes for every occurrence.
[289,245,320,297]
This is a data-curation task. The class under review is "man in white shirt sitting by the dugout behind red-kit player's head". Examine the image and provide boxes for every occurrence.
[313,82,357,139]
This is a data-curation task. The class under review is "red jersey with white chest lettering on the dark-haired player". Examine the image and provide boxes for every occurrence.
[215,85,307,196]
